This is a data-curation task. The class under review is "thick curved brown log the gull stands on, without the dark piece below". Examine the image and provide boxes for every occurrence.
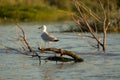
[38,48,83,62]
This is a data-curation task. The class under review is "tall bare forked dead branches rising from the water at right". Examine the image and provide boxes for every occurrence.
[73,0,110,52]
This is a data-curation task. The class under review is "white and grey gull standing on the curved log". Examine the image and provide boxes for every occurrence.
[38,25,59,47]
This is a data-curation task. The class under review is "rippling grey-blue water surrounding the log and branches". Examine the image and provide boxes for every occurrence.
[0,23,120,80]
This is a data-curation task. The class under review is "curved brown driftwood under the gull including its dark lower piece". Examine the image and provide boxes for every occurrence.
[38,48,83,62]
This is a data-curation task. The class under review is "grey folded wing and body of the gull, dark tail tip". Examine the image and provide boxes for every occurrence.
[41,32,59,42]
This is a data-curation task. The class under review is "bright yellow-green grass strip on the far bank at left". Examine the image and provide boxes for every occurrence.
[0,5,69,22]
